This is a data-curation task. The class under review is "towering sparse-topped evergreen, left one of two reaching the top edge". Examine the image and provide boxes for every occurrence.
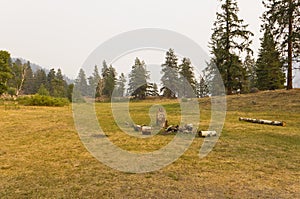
[210,0,253,94]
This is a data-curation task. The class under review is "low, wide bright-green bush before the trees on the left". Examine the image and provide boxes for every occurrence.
[18,94,69,106]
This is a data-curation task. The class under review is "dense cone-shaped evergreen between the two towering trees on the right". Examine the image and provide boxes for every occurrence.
[256,29,285,90]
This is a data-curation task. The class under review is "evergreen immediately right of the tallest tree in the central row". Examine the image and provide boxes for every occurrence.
[179,58,196,97]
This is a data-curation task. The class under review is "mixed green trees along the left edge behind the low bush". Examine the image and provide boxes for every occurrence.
[0,51,73,99]
